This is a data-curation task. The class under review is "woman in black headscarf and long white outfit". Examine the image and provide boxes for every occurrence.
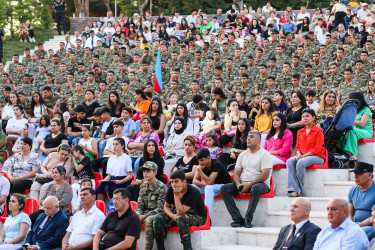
[164,117,187,176]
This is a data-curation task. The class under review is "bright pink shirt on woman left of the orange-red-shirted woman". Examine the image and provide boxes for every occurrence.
[264,129,293,162]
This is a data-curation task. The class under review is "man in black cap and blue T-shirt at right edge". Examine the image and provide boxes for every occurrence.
[348,162,375,234]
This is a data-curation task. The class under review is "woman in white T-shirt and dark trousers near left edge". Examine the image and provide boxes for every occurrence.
[5,104,27,155]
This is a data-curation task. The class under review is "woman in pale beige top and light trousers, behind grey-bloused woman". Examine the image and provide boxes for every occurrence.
[30,145,73,200]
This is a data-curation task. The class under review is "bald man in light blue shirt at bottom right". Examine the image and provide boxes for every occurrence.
[314,198,369,250]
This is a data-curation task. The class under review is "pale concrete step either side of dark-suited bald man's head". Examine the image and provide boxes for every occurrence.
[266,211,329,228]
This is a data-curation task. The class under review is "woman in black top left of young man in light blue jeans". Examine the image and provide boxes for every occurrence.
[172,135,199,184]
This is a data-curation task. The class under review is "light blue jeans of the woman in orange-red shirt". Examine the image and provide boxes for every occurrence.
[286,155,324,193]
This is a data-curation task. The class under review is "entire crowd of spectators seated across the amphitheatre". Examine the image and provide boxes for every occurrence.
[0,1,375,249]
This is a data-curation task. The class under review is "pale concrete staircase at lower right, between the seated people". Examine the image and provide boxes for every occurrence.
[138,169,354,250]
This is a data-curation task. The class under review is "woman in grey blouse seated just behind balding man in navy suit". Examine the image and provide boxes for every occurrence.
[30,166,73,225]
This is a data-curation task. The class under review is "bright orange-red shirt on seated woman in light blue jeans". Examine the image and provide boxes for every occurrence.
[295,125,325,158]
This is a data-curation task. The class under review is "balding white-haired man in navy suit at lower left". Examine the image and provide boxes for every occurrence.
[24,196,69,250]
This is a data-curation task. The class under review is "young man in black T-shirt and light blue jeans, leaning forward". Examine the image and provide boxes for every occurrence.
[193,148,232,214]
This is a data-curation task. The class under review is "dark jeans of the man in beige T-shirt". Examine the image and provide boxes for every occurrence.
[220,182,270,223]
